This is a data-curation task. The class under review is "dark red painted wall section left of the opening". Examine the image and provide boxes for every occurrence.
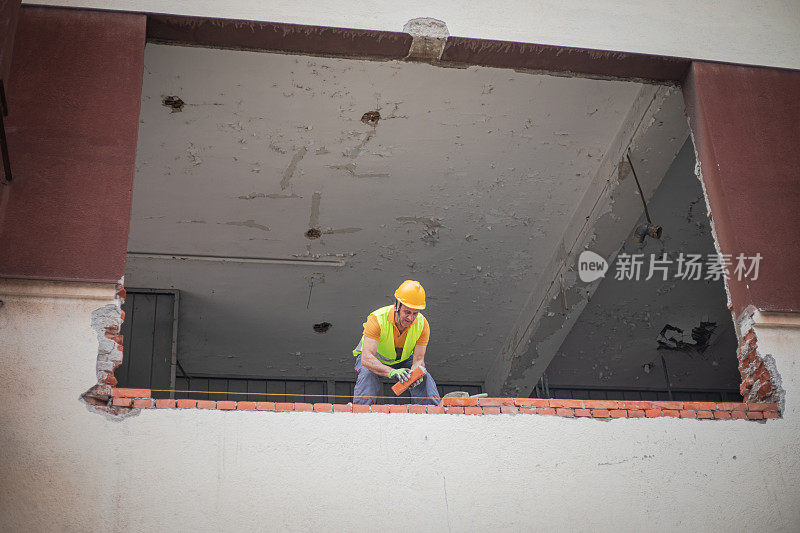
[0,7,146,282]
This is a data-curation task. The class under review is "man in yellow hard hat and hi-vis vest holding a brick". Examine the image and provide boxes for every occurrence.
[353,280,440,405]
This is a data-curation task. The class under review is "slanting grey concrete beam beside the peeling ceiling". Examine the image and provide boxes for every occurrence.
[486,86,688,396]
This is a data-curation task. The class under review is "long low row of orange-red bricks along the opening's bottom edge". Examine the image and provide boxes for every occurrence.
[110,388,780,422]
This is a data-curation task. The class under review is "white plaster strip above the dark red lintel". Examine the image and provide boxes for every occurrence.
[25,0,800,69]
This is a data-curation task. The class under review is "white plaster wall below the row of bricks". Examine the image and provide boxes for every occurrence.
[0,284,800,531]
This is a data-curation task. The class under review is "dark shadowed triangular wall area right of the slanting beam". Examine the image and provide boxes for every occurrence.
[546,139,739,394]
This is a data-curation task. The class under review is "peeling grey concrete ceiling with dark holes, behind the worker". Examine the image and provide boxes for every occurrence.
[126,44,664,381]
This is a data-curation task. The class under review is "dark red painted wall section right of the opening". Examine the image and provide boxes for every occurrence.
[683,62,800,317]
